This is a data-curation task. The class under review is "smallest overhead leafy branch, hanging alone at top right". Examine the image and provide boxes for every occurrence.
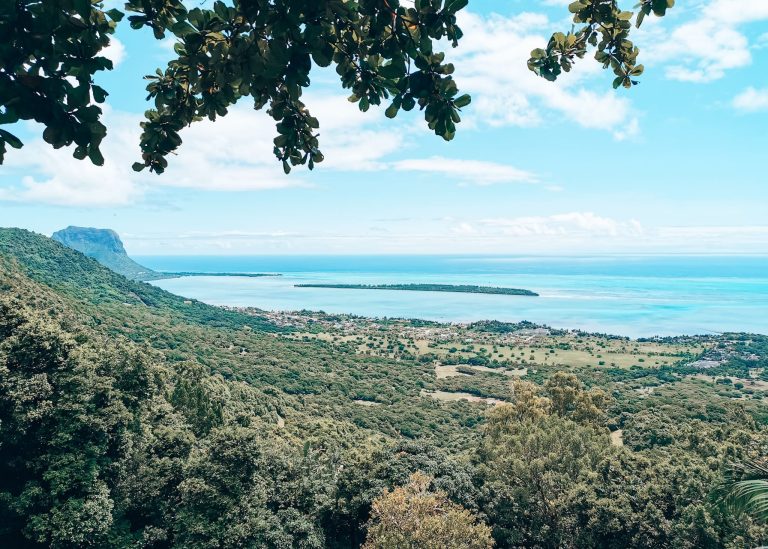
[528,0,675,89]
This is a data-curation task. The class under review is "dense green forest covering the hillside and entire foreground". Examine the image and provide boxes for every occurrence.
[0,225,768,549]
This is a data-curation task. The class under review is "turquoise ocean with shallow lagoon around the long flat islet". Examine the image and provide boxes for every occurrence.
[136,256,768,337]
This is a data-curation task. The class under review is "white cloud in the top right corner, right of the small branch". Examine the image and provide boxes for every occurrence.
[636,0,768,83]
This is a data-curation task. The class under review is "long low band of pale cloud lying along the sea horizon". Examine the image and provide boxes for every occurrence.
[123,218,768,254]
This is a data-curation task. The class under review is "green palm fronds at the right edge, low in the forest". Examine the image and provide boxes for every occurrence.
[715,460,768,522]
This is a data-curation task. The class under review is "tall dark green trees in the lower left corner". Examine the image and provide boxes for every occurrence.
[0,301,154,547]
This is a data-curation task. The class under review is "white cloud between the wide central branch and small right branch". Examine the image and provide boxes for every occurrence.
[449,12,639,138]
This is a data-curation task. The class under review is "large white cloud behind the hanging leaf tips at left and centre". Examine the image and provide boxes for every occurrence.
[0,95,407,206]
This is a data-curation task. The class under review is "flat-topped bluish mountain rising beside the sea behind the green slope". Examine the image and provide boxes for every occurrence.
[51,225,165,280]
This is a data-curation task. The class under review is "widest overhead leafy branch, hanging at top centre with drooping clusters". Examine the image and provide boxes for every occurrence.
[127,0,469,172]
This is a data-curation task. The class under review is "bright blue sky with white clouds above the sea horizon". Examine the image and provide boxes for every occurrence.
[0,0,768,255]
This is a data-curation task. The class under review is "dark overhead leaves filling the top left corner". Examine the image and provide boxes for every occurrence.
[0,0,122,166]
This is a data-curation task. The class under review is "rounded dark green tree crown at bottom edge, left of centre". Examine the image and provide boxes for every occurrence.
[174,427,333,549]
